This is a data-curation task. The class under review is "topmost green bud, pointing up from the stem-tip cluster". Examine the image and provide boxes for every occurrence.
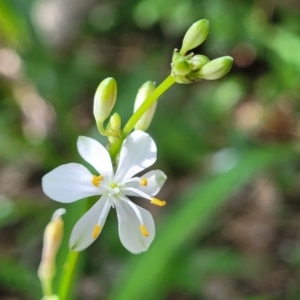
[180,19,209,54]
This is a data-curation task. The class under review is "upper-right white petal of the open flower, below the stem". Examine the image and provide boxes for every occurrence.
[115,130,157,181]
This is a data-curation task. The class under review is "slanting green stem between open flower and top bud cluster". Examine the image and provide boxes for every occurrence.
[109,75,175,160]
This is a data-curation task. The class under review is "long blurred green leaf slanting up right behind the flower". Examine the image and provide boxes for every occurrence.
[109,146,295,300]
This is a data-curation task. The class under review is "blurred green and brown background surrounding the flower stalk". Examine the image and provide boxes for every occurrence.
[0,0,300,300]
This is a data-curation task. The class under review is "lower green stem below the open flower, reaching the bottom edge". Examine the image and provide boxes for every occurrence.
[58,251,79,300]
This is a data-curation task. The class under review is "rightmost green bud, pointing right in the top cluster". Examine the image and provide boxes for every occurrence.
[197,56,233,80]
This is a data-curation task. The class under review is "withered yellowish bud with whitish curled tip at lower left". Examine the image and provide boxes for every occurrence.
[38,208,66,294]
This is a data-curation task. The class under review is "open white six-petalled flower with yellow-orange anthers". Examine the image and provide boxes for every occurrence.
[42,130,166,253]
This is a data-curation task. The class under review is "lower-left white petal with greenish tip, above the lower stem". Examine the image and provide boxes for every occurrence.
[69,196,110,251]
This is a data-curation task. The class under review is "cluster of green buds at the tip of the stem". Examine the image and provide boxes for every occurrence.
[171,19,233,83]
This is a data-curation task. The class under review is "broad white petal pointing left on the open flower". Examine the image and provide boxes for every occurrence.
[42,163,102,203]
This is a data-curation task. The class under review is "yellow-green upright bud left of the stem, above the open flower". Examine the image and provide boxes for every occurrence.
[94,77,117,124]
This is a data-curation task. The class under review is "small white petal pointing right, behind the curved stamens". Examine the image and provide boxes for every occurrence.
[125,170,167,197]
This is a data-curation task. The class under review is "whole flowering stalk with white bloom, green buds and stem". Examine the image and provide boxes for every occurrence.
[39,20,233,300]
